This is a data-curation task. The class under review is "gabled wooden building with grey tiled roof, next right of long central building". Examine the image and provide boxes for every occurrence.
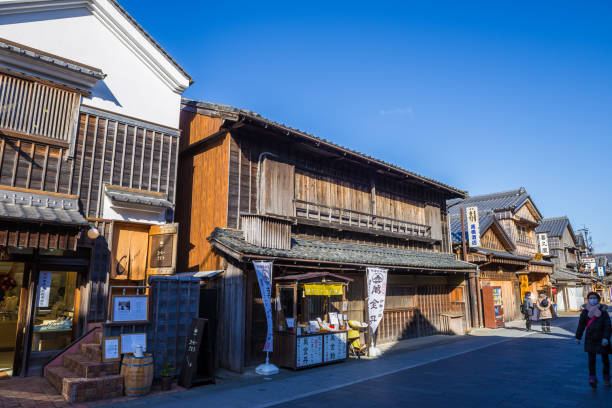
[449,188,553,321]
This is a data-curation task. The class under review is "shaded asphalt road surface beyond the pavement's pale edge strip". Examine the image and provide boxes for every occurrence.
[276,318,612,408]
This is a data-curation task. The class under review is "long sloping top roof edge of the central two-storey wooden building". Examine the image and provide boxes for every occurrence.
[182,98,467,198]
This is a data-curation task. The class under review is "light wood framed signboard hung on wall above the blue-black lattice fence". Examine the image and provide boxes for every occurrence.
[147,223,178,275]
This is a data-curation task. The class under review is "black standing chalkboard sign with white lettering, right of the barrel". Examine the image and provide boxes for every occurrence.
[178,318,214,388]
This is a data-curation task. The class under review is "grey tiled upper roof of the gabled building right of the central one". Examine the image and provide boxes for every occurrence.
[447,187,541,220]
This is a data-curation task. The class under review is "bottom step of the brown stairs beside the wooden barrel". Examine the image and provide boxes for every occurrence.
[45,366,123,402]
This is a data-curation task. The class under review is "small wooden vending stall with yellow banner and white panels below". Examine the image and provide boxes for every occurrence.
[273,272,352,370]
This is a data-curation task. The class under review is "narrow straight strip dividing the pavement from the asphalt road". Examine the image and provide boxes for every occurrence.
[253,322,575,408]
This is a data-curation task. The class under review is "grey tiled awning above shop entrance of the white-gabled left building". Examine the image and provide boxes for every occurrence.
[0,187,89,251]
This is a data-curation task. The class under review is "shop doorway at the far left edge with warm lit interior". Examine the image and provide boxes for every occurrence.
[0,262,24,378]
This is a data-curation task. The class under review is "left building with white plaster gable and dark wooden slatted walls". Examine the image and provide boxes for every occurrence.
[0,0,190,376]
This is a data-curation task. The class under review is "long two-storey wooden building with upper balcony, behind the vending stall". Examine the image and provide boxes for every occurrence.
[176,100,475,371]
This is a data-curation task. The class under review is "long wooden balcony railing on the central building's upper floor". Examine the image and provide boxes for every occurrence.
[294,200,431,238]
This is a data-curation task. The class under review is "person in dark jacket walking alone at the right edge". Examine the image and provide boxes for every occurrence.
[576,292,612,388]
